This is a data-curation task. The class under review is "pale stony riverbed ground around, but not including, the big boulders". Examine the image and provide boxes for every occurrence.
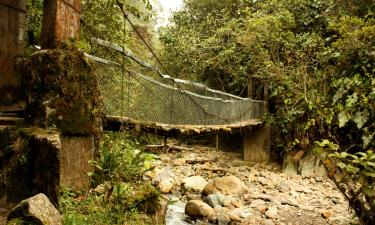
[147,146,355,225]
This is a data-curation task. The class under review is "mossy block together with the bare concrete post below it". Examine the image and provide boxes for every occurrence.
[26,48,101,189]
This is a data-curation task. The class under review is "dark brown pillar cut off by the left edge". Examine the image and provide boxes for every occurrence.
[0,0,26,111]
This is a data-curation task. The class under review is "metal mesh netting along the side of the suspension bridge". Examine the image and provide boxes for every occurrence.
[90,53,263,126]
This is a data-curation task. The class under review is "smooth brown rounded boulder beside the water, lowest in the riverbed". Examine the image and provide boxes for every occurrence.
[185,200,216,220]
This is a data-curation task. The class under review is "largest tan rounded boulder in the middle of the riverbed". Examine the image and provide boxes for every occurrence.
[203,176,250,195]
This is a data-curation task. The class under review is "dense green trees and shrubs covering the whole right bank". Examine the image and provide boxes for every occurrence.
[161,0,375,224]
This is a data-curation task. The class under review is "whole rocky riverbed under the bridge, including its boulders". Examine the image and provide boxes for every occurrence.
[144,143,356,225]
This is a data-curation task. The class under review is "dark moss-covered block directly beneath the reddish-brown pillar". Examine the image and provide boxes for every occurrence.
[26,47,101,136]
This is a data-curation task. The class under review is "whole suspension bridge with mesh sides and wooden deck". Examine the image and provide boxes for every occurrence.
[86,38,265,134]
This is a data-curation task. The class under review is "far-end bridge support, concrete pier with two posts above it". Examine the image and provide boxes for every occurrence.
[243,76,271,162]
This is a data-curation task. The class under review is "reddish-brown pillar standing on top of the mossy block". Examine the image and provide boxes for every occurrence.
[41,0,81,49]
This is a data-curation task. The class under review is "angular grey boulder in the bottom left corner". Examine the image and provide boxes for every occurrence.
[7,194,62,225]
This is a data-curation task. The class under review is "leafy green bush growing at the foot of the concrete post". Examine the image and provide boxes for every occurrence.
[59,133,159,225]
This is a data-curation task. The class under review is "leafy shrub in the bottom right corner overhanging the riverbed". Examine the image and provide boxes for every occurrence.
[316,139,375,224]
